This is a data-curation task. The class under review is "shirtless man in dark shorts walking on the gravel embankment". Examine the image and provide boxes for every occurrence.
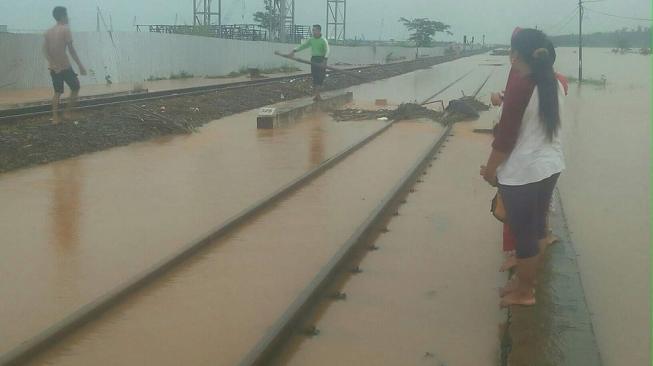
[43,6,86,124]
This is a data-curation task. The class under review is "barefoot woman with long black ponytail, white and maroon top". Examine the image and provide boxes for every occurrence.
[481,29,564,307]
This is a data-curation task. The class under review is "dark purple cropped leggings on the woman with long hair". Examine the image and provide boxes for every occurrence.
[499,173,560,258]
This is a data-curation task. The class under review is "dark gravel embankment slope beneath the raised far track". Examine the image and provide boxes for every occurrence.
[0,54,474,173]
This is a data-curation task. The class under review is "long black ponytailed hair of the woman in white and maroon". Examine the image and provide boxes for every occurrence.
[510,29,560,140]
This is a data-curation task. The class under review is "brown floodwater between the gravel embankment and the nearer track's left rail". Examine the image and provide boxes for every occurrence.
[0,108,382,353]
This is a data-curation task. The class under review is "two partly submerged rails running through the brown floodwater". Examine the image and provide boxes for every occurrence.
[0,66,478,365]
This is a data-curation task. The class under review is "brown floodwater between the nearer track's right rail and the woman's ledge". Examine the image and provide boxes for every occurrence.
[279,121,506,366]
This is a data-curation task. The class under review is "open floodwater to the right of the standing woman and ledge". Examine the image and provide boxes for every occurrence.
[558,49,651,366]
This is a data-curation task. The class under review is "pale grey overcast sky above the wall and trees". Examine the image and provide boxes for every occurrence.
[0,0,651,43]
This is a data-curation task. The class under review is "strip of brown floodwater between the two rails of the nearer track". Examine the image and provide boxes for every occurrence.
[25,122,441,365]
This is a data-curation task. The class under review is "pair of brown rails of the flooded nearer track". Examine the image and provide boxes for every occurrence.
[0,68,488,365]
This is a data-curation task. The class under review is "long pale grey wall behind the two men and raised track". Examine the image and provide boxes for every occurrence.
[0,32,444,89]
